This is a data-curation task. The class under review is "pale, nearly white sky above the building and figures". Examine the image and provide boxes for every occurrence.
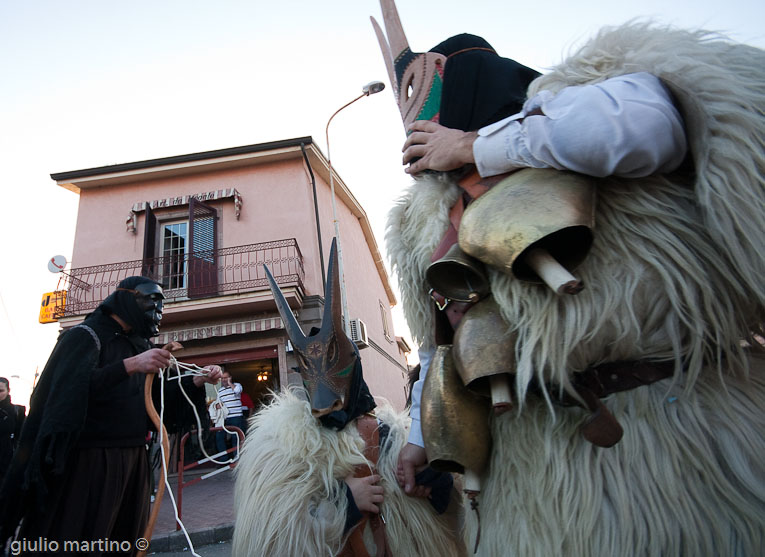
[0,0,765,404]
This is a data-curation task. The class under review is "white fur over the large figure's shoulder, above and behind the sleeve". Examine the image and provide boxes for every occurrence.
[529,22,765,319]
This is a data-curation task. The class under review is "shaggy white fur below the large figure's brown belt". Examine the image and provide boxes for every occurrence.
[466,360,765,557]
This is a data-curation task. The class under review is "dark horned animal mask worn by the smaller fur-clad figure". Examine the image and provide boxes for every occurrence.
[266,240,359,418]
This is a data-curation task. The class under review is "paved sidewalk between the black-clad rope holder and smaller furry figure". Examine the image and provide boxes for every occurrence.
[149,469,234,553]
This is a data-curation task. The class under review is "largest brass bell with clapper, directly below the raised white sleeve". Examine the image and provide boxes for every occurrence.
[459,168,595,294]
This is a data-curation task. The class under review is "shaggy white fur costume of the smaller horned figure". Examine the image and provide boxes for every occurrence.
[232,392,465,557]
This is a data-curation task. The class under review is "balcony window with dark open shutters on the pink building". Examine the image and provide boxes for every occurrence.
[143,198,218,298]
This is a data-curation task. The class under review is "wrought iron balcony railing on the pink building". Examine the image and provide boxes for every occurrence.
[56,238,305,317]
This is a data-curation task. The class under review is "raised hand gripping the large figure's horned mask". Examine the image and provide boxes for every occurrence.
[402,120,478,174]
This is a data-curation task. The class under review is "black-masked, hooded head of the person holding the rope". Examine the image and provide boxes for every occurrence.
[99,276,165,339]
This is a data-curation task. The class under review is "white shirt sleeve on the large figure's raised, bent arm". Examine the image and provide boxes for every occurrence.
[473,72,687,178]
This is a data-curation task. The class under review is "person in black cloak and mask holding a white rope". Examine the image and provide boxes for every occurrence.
[0,277,220,553]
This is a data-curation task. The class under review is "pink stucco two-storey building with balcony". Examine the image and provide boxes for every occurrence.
[51,137,408,409]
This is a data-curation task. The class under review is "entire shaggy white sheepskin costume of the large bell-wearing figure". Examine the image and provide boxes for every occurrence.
[386,23,765,557]
